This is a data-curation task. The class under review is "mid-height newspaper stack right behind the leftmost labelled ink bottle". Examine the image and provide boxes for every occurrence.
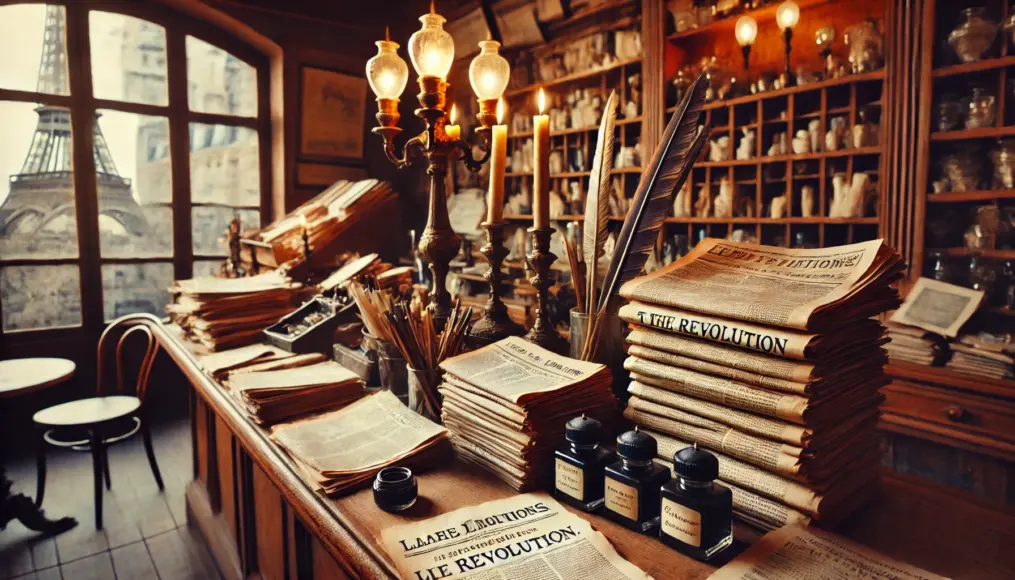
[439,336,619,491]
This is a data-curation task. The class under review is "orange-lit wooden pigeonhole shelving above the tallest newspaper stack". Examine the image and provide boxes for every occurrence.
[664,0,889,247]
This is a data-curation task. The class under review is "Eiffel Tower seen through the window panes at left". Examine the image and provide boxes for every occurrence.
[0,6,147,240]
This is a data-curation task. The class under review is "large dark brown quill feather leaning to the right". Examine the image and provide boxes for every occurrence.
[596,75,707,318]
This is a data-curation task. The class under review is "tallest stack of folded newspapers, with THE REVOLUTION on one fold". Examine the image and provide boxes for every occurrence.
[620,240,902,529]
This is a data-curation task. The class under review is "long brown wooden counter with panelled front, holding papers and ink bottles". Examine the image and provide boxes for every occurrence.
[129,316,1015,580]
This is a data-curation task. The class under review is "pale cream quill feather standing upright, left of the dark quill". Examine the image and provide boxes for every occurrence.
[582,91,617,313]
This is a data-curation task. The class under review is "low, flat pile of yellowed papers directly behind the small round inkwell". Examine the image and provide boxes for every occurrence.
[271,391,448,496]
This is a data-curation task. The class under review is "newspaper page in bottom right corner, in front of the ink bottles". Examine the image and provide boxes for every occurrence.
[708,525,947,580]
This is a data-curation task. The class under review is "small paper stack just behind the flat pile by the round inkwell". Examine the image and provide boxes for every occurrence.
[223,361,363,425]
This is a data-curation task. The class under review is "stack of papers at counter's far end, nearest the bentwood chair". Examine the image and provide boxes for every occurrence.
[165,271,305,351]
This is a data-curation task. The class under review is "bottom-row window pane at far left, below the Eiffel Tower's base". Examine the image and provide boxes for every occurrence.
[0,265,81,332]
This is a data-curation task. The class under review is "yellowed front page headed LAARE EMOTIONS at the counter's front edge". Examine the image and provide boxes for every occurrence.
[381,493,650,580]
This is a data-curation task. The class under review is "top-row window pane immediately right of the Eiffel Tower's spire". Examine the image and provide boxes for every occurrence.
[88,11,170,106]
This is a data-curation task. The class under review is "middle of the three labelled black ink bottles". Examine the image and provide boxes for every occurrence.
[605,427,670,532]
